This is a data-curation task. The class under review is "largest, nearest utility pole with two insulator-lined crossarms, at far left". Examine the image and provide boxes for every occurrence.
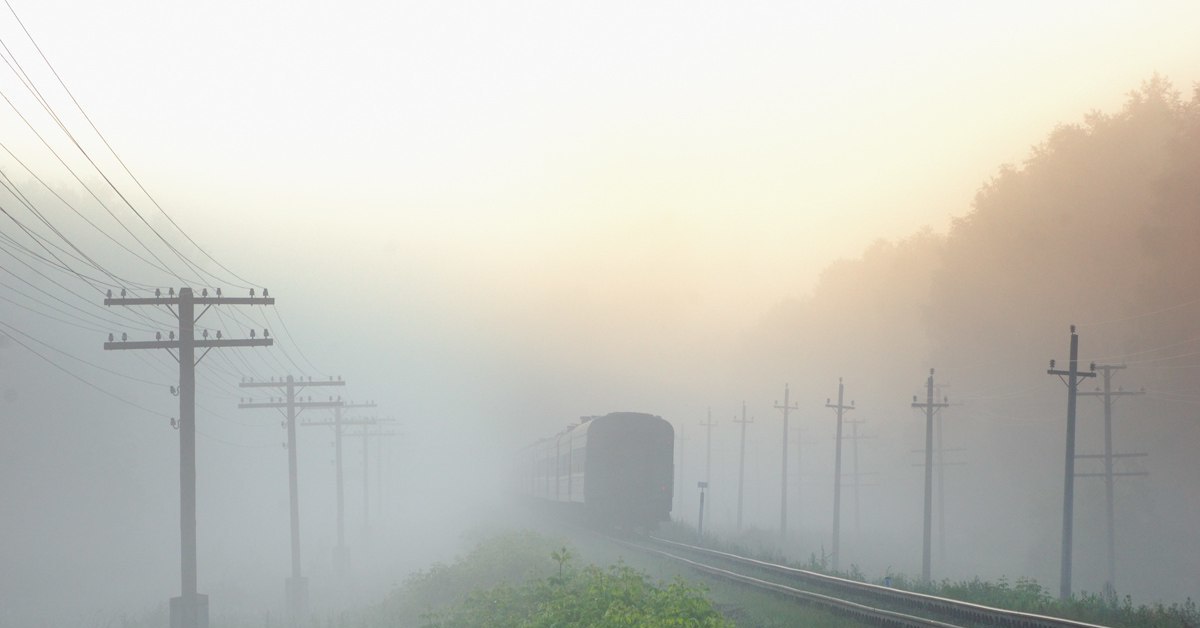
[104,288,275,628]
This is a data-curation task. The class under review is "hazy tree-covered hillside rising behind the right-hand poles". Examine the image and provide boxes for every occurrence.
[745,76,1200,596]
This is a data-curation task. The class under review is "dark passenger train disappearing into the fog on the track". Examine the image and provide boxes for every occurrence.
[515,412,674,531]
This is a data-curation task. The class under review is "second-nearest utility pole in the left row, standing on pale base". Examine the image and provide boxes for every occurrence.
[238,375,346,626]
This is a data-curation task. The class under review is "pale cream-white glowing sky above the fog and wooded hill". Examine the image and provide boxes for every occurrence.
[5,0,1200,338]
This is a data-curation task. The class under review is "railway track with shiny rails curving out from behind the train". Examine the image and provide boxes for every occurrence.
[606,537,1104,628]
